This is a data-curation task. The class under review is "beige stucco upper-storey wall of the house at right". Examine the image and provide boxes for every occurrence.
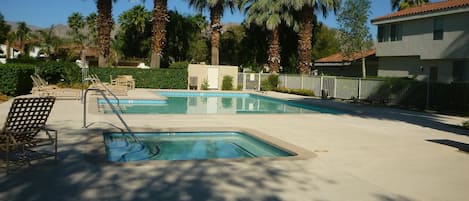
[376,12,469,60]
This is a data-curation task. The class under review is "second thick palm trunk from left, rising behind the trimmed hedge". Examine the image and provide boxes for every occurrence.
[150,0,169,68]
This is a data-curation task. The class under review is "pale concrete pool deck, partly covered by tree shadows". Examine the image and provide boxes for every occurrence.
[0,89,469,201]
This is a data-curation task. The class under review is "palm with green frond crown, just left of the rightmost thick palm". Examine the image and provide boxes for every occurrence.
[240,0,294,74]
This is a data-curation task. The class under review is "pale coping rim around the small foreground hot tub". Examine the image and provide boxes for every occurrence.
[84,127,317,166]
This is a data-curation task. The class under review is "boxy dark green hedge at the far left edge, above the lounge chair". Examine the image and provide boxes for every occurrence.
[0,64,34,96]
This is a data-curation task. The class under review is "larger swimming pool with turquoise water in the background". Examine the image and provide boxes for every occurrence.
[98,91,343,114]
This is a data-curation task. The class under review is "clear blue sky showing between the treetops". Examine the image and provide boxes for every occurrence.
[0,0,392,36]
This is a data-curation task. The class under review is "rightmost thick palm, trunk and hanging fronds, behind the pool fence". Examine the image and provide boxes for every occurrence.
[285,0,340,75]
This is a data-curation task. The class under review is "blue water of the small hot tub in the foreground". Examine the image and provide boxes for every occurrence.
[103,131,296,162]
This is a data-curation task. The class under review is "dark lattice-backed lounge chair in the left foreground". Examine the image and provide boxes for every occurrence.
[0,97,57,174]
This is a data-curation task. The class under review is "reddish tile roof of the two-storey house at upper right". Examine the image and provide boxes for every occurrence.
[371,0,469,22]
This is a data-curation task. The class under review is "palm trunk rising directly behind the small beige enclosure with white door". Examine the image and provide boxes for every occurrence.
[210,5,223,65]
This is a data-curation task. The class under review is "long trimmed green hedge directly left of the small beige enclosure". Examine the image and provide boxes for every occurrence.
[90,68,187,89]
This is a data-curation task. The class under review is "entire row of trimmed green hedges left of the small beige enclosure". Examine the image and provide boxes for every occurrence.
[0,60,187,96]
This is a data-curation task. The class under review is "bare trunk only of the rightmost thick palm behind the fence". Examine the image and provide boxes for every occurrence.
[298,6,314,75]
